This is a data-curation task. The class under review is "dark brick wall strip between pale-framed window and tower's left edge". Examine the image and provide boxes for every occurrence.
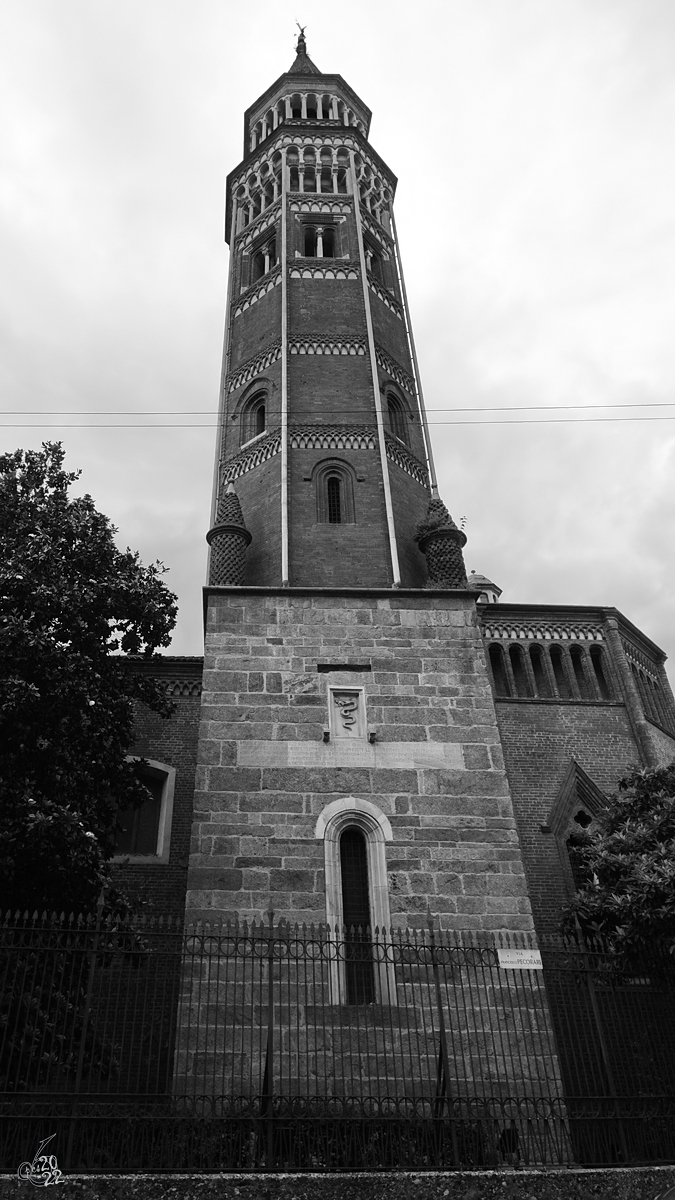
[114,655,203,917]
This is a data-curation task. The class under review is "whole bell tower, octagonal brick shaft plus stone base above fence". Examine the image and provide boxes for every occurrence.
[187,35,532,931]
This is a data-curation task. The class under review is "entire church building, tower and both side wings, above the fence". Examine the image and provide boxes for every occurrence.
[118,36,675,955]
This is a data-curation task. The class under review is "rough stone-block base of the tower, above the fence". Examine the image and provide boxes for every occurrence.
[186,588,532,931]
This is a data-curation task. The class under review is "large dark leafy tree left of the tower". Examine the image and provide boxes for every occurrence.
[0,443,177,912]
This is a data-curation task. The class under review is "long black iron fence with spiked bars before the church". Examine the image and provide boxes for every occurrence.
[0,918,675,1171]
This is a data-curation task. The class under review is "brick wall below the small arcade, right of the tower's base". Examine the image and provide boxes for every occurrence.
[487,700,640,935]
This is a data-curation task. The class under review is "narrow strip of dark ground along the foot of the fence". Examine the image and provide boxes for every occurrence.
[0,1166,675,1200]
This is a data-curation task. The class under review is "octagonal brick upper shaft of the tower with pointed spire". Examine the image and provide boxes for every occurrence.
[209,32,444,588]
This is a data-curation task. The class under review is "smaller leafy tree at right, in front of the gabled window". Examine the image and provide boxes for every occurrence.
[563,762,675,959]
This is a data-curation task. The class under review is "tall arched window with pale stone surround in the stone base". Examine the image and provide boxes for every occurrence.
[315,796,396,1004]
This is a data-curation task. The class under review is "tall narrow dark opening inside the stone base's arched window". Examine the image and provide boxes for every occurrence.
[340,828,375,1004]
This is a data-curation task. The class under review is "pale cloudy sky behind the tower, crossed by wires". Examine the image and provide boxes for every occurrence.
[0,0,675,679]
